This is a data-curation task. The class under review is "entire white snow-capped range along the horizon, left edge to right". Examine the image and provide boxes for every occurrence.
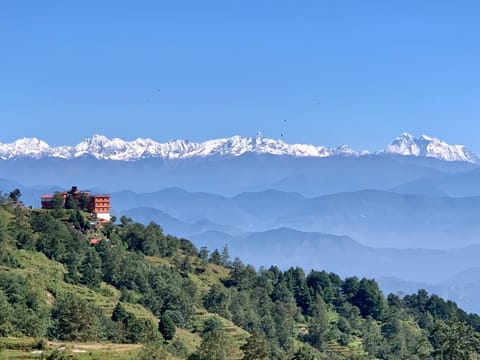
[0,133,479,163]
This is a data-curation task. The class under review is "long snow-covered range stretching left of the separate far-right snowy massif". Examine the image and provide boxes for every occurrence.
[0,133,359,161]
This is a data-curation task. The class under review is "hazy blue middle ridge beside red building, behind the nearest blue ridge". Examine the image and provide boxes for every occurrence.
[111,188,480,249]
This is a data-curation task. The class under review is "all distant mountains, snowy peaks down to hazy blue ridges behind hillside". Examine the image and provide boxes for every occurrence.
[0,133,480,311]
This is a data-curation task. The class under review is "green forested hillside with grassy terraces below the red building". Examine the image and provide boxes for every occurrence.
[0,190,480,360]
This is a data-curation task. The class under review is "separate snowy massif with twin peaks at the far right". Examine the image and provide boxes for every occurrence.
[380,133,479,163]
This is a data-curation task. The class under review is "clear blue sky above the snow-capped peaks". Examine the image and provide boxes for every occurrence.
[0,0,480,153]
